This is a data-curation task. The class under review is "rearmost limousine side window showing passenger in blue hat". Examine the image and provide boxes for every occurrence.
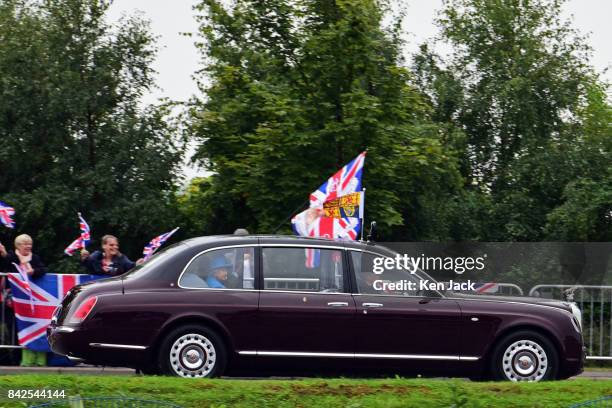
[179,247,255,289]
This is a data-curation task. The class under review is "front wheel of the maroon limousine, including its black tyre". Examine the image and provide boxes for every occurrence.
[491,330,559,382]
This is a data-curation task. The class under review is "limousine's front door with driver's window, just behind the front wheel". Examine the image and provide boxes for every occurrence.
[349,250,461,360]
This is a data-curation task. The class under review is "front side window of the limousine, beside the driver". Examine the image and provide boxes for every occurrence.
[350,251,439,297]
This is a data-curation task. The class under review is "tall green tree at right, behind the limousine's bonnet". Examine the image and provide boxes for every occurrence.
[414,0,611,241]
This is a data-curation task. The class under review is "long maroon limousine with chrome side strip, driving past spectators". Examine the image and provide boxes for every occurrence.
[48,236,585,381]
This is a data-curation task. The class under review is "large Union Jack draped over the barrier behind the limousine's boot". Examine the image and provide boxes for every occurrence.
[8,273,102,351]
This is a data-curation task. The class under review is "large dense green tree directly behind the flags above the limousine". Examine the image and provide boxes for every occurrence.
[191,0,461,239]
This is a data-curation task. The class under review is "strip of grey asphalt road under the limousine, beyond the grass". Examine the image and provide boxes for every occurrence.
[0,366,612,380]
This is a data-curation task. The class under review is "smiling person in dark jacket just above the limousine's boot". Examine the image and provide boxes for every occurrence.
[81,235,143,276]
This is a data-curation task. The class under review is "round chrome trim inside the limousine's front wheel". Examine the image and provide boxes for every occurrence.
[502,340,548,381]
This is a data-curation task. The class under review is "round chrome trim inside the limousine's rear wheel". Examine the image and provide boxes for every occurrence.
[169,333,217,378]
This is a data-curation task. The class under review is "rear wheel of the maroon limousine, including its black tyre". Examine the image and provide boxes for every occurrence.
[159,325,227,378]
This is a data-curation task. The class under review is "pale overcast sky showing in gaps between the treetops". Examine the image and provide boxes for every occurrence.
[108,0,612,180]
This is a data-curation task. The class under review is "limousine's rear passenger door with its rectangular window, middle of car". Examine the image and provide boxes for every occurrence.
[258,244,356,358]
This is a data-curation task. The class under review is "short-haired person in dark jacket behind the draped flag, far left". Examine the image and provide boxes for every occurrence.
[0,234,47,367]
